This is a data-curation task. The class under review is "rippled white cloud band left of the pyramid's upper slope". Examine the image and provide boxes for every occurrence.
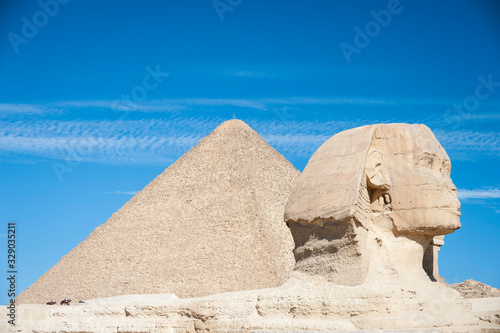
[0,119,219,164]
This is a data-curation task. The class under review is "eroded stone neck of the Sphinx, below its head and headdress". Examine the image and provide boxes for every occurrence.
[289,212,438,286]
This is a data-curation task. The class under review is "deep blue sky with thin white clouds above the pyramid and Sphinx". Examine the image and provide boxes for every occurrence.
[0,0,500,304]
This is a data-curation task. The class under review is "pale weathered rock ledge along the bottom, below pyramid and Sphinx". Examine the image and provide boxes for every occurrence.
[6,277,500,333]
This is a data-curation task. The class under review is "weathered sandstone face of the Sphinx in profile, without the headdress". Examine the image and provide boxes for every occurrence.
[372,125,460,235]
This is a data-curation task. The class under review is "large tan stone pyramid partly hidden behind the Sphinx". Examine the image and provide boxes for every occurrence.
[18,120,300,304]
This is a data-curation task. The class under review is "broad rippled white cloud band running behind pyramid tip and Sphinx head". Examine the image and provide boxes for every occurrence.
[0,117,500,165]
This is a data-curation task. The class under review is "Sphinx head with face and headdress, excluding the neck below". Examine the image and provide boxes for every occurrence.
[285,124,460,235]
